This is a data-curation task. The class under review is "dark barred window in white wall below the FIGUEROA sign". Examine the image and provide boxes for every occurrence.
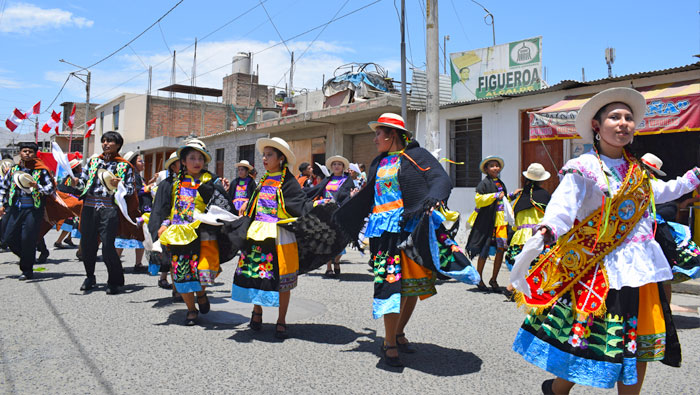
[449,117,481,188]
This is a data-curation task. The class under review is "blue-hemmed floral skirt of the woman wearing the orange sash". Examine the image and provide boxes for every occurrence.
[513,283,680,388]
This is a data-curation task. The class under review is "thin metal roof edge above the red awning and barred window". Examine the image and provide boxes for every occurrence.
[440,62,700,108]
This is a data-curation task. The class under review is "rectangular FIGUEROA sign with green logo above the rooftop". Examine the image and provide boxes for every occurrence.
[450,37,542,101]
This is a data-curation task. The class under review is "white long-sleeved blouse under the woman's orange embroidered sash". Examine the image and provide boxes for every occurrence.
[541,150,700,290]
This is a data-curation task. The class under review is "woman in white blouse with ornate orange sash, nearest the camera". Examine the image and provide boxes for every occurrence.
[511,88,700,394]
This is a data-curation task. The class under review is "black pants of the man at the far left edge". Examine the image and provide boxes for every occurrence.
[3,206,44,277]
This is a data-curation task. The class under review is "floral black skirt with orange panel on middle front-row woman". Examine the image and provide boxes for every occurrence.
[231,226,299,307]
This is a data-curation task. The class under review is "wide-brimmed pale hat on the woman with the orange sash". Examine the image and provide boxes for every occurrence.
[576,88,647,143]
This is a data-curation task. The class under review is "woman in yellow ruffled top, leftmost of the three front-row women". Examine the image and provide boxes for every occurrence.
[148,139,231,326]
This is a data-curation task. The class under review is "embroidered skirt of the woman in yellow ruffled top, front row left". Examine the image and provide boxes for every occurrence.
[168,232,221,293]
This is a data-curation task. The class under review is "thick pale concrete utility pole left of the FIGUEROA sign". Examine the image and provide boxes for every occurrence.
[425,0,440,152]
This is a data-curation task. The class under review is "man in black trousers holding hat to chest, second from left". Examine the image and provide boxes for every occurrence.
[72,132,134,295]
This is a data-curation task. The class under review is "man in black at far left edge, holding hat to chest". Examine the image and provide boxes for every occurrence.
[0,142,56,281]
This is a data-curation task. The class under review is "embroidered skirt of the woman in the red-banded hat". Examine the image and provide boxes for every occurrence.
[369,232,437,319]
